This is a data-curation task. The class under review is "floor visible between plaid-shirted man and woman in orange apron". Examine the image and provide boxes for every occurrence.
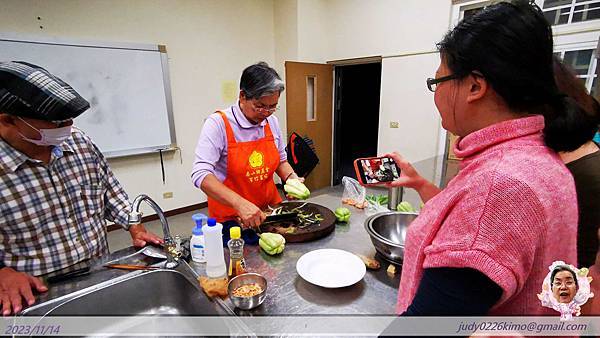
[108,208,208,252]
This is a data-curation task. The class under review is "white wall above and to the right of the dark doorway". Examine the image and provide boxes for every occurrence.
[288,0,451,161]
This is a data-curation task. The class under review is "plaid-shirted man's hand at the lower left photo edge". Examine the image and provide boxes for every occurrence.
[0,267,48,316]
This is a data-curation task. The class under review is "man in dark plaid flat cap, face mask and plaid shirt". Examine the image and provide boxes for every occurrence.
[0,62,162,316]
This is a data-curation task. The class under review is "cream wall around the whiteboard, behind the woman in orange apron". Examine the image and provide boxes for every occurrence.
[0,0,275,217]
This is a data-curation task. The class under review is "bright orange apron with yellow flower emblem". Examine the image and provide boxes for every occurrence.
[208,112,281,223]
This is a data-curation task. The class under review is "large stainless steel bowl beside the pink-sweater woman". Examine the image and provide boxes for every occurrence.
[365,211,419,263]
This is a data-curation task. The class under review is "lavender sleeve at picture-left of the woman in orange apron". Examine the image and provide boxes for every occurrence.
[192,114,225,188]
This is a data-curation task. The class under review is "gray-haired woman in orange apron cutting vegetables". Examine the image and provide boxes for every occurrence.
[192,62,298,243]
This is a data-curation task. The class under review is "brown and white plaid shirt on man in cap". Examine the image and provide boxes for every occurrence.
[0,128,131,276]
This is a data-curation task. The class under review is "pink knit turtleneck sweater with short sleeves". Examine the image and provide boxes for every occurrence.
[397,115,577,315]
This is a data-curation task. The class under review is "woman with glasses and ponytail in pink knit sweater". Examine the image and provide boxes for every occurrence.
[388,1,583,315]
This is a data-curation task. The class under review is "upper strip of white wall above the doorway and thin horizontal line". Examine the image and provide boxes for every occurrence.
[298,0,451,62]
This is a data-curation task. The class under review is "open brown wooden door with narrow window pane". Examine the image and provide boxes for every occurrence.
[285,61,333,189]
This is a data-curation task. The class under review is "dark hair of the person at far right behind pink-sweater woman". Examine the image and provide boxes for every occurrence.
[550,56,600,150]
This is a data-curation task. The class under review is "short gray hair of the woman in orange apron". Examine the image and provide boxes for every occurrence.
[240,61,285,99]
